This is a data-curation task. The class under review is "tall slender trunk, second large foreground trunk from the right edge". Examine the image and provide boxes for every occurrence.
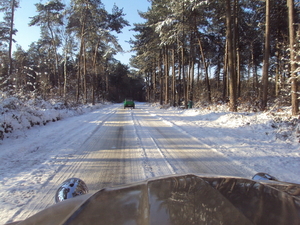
[262,0,270,110]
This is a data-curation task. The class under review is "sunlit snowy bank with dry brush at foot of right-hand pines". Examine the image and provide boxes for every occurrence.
[149,103,300,143]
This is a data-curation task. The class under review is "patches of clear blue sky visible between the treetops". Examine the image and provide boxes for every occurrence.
[14,0,150,64]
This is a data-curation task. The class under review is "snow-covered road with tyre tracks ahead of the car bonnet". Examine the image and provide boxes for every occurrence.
[0,104,299,224]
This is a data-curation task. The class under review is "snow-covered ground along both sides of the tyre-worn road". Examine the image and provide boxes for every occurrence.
[0,98,300,224]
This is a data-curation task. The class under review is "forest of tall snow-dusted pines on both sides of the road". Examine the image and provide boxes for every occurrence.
[0,0,300,115]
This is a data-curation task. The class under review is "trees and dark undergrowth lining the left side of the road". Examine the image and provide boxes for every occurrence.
[0,0,143,104]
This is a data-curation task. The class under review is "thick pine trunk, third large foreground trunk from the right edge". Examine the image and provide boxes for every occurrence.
[226,0,237,112]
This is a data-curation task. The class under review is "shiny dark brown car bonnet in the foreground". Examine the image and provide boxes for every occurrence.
[4,174,300,225]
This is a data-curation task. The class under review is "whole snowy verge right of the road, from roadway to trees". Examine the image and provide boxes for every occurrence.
[144,105,300,183]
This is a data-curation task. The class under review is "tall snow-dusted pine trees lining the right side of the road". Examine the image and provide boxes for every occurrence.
[131,0,300,115]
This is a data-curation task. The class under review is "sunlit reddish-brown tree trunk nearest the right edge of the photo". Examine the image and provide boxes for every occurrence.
[287,0,299,115]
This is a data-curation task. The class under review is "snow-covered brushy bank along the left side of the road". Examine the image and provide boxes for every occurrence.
[0,96,106,140]
